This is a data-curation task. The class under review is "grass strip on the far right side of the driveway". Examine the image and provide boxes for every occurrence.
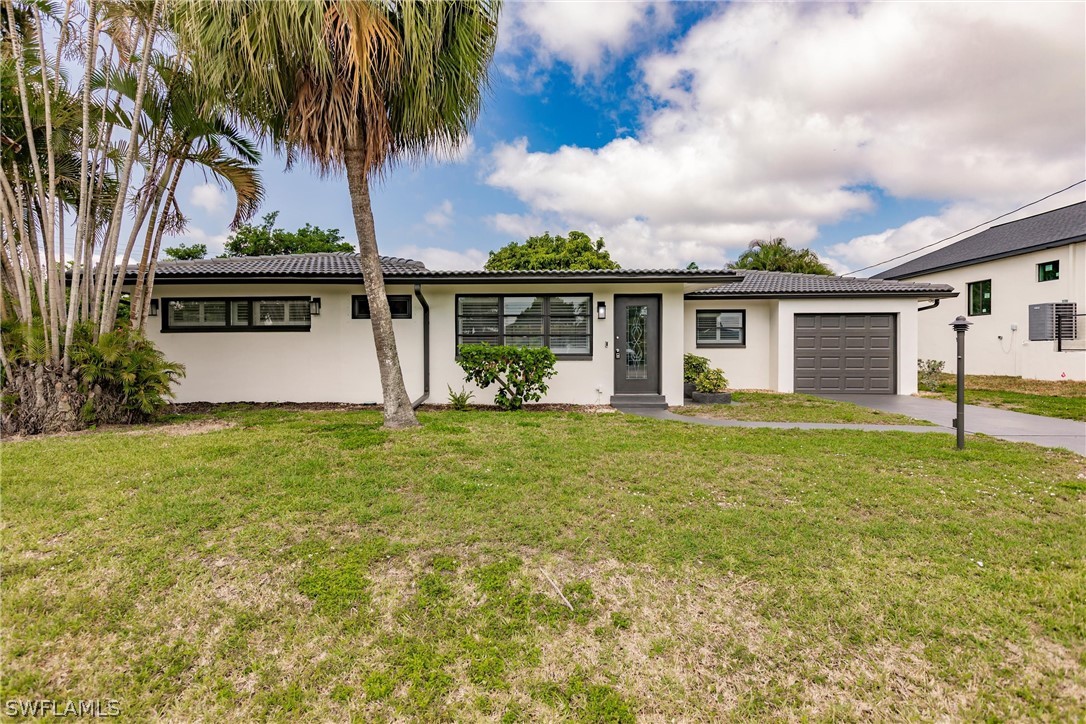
[937,374,1086,421]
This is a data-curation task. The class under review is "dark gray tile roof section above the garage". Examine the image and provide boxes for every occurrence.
[686,269,957,299]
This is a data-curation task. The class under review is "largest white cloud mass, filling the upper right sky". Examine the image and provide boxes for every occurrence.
[488,3,1086,268]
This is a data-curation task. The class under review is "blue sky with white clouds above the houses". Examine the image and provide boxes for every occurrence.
[167,2,1086,274]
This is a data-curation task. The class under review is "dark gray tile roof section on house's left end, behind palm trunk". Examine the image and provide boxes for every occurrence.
[128,252,427,279]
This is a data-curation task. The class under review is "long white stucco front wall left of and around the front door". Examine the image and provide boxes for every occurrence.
[149,282,683,405]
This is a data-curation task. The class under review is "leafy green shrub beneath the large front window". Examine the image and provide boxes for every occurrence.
[457,344,557,410]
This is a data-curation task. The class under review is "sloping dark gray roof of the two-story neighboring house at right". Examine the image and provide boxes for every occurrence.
[874,201,1086,279]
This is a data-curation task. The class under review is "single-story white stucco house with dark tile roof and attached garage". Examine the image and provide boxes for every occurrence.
[129,253,955,405]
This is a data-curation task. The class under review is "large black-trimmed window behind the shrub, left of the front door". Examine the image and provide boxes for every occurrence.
[456,294,592,359]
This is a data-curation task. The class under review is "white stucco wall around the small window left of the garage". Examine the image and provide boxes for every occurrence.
[683,300,776,390]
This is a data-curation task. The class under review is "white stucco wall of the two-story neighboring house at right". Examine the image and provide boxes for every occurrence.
[909,243,1086,380]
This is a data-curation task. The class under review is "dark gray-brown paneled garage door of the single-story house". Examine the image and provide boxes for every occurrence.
[795,314,897,395]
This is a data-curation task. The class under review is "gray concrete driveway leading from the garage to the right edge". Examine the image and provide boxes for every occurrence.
[820,394,1086,455]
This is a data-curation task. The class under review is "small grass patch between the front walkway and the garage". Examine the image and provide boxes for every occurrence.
[672,392,931,425]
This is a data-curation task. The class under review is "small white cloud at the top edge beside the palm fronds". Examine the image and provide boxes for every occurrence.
[498,0,671,79]
